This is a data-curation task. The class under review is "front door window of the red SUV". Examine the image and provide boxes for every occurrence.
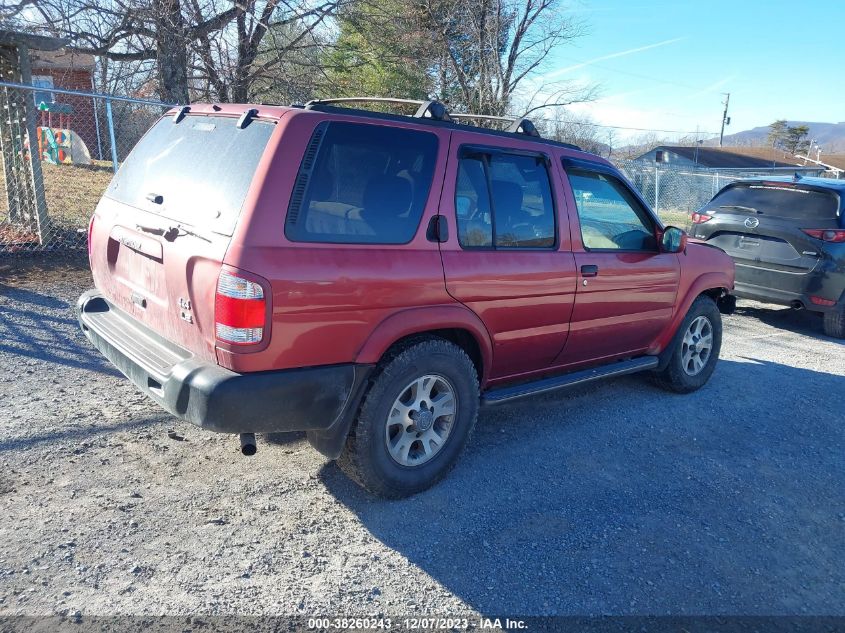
[567,169,657,251]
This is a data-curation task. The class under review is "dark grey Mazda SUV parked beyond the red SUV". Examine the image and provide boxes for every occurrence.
[692,177,845,338]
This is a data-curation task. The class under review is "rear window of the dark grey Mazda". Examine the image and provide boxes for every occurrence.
[706,185,839,220]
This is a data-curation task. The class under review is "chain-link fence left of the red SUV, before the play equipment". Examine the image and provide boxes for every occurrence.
[0,82,169,253]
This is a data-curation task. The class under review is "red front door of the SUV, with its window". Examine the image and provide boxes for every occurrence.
[557,163,682,364]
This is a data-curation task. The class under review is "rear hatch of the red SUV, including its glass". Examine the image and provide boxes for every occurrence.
[90,114,275,361]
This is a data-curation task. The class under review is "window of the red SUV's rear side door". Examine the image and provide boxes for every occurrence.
[455,151,555,248]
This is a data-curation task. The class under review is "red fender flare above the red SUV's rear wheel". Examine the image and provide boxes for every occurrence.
[355,305,493,376]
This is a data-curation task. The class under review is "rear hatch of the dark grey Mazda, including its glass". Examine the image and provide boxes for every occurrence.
[692,181,840,291]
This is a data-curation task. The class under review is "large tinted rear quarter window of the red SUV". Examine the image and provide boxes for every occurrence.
[285,122,437,244]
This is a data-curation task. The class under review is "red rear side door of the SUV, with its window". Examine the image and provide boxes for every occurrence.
[440,132,575,380]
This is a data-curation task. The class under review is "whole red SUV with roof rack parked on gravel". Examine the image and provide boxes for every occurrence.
[78,101,733,497]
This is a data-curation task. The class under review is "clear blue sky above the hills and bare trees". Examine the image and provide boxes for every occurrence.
[538,0,845,140]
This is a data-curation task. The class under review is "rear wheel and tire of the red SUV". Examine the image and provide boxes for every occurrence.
[338,339,478,499]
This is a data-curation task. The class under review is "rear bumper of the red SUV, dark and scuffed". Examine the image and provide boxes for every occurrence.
[77,290,371,442]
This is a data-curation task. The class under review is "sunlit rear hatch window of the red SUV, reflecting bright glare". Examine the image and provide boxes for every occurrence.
[106,115,274,235]
